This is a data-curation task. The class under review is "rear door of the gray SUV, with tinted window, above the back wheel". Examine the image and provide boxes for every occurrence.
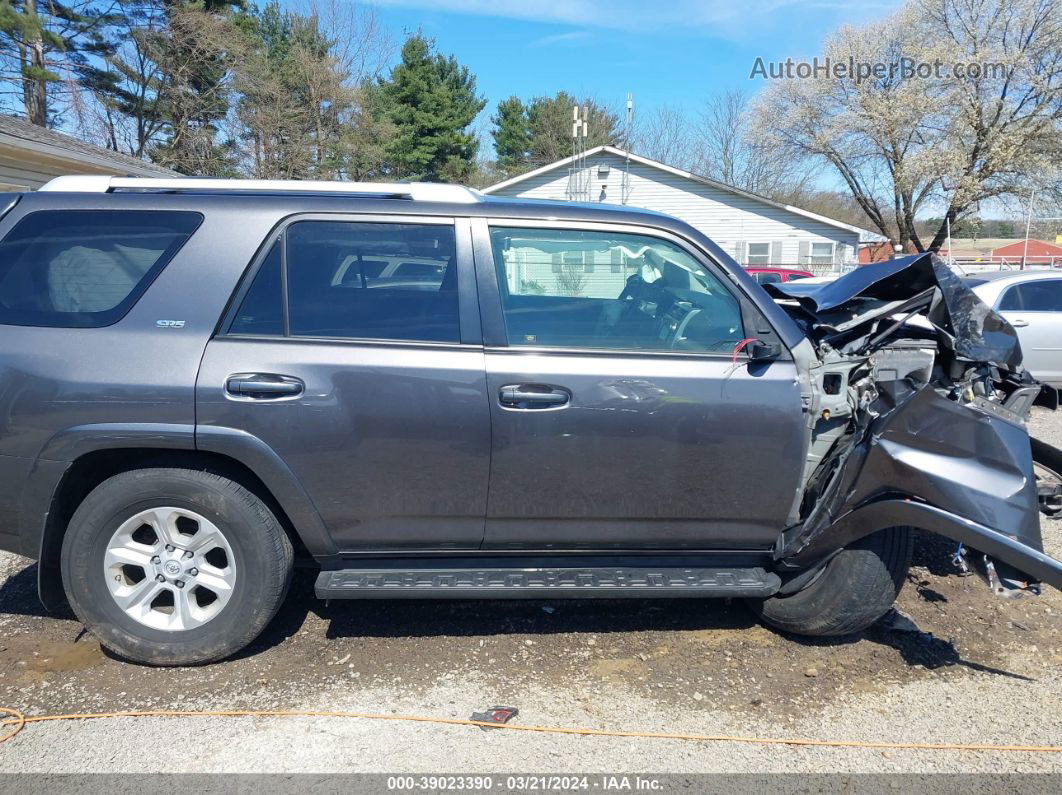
[196,215,491,551]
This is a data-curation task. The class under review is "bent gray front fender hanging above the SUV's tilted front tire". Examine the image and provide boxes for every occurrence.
[775,388,1062,589]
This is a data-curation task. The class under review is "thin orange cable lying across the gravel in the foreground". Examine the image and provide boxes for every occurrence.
[0,707,1062,754]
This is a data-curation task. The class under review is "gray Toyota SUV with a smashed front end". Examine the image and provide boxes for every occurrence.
[0,177,1062,664]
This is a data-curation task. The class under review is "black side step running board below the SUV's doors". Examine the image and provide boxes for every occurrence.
[316,560,782,599]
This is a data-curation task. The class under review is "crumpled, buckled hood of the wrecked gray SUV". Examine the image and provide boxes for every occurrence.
[764,254,1022,370]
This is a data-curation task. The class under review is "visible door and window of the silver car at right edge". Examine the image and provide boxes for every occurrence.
[999,278,1062,384]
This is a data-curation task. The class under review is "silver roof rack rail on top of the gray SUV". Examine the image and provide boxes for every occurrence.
[39,176,483,204]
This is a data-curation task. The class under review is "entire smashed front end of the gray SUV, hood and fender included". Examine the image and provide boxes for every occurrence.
[765,255,1062,597]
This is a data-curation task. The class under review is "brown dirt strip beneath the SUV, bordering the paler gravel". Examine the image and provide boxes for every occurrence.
[0,536,1062,716]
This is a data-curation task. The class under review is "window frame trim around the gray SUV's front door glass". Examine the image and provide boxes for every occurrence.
[473,217,792,361]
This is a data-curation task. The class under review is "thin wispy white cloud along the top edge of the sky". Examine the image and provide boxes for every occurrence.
[373,0,823,30]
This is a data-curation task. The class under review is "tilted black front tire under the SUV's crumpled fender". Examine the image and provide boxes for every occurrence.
[750,528,913,636]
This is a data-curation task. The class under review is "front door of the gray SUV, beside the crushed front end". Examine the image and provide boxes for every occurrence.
[476,220,804,549]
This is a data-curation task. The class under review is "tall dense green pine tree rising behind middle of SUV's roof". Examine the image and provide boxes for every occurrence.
[376,33,486,182]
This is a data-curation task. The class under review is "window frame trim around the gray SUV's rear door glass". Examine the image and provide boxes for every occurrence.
[215,212,483,350]
